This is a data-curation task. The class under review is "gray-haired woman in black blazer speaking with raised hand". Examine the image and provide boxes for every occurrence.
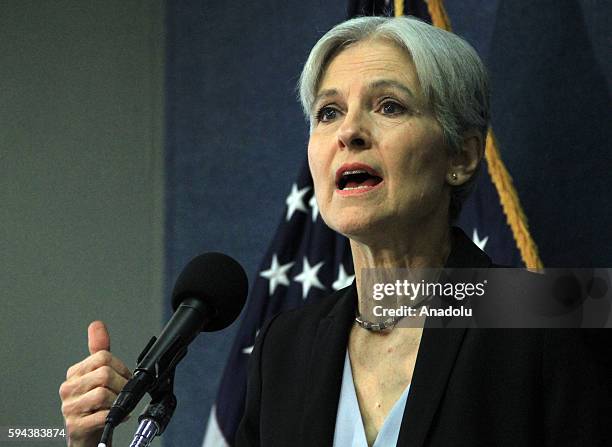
[60,17,610,447]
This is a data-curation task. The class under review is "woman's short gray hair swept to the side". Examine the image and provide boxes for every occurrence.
[298,17,490,220]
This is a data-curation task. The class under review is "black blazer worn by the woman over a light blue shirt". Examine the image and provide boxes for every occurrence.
[236,229,612,447]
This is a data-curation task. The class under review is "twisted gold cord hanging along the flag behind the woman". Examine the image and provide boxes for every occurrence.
[394,0,543,269]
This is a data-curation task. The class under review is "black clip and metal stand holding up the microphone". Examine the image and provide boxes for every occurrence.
[130,368,176,447]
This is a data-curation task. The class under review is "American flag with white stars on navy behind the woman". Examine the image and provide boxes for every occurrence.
[203,0,523,447]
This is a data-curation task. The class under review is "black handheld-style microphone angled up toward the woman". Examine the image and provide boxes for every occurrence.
[106,253,248,432]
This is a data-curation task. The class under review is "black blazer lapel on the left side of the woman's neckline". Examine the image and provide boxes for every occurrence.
[299,283,357,447]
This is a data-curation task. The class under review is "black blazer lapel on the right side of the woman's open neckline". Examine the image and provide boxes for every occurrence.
[397,227,491,447]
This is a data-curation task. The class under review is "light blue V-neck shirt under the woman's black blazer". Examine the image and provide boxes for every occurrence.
[334,350,410,447]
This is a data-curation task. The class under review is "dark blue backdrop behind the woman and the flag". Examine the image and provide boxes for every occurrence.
[163,0,612,447]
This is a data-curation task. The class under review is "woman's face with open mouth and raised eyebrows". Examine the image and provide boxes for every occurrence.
[308,40,450,242]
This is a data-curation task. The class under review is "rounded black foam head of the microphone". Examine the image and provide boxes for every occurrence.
[172,253,249,332]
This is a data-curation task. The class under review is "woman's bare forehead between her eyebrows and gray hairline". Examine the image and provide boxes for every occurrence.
[318,39,420,93]
